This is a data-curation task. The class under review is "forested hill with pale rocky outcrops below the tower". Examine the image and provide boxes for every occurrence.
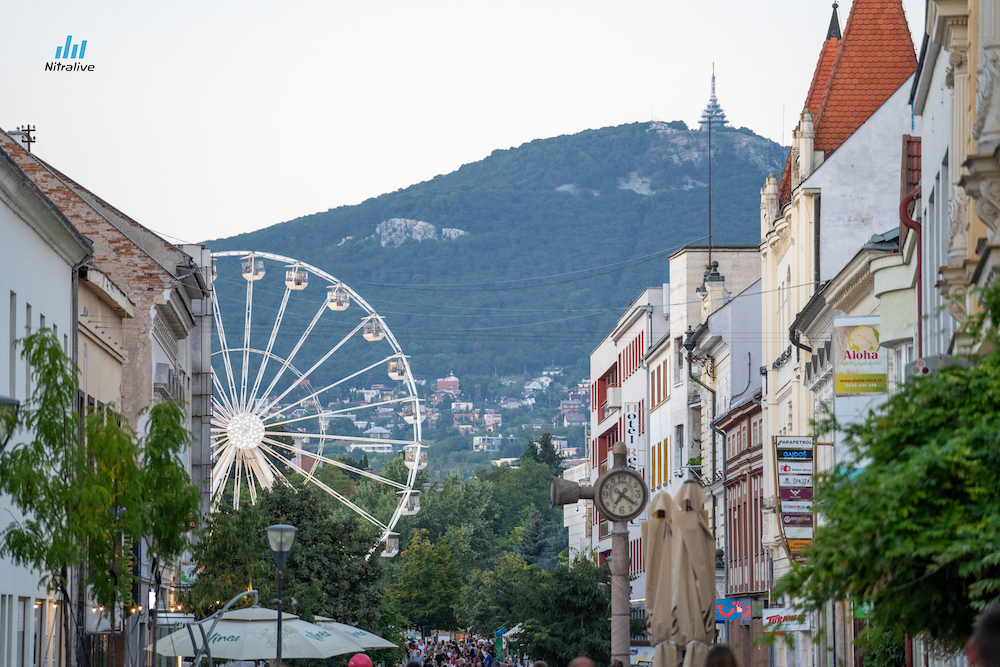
[207,121,785,378]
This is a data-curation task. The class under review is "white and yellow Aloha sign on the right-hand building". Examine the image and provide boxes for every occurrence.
[833,317,888,396]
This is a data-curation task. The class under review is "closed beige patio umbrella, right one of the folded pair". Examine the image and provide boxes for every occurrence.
[670,480,715,644]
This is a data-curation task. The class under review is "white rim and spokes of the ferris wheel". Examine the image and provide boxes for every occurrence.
[211,250,425,557]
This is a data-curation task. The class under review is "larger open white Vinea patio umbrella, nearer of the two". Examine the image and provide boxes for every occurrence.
[146,607,365,660]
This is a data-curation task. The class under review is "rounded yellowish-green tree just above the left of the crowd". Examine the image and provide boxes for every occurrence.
[390,529,462,630]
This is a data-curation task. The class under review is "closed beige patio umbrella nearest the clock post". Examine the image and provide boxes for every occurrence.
[642,491,677,648]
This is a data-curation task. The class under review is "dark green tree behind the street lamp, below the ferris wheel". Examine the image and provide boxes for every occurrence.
[189,484,382,632]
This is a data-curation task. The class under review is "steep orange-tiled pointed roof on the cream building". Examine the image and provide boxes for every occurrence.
[778,0,917,202]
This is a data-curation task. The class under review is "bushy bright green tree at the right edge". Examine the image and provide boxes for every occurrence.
[779,283,1000,648]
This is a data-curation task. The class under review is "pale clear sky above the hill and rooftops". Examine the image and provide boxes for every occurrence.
[0,0,924,247]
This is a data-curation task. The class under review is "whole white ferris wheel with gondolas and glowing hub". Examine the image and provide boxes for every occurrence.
[211,251,427,557]
